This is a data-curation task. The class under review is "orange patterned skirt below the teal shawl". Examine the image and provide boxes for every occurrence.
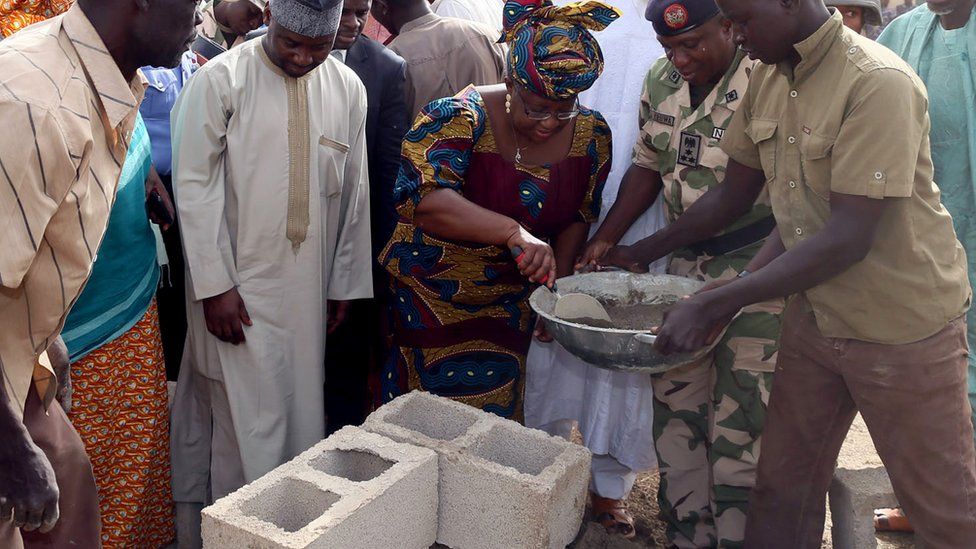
[67,300,175,549]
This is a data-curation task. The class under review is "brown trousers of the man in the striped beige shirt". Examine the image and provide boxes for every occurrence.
[0,385,102,549]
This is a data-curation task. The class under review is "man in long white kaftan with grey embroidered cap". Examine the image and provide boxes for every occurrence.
[172,0,372,535]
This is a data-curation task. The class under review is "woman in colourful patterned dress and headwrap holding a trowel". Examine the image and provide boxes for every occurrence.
[380,0,619,420]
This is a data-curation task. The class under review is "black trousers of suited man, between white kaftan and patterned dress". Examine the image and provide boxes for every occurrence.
[325,294,389,436]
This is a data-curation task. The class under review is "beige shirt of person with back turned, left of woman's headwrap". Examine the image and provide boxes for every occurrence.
[389,13,506,120]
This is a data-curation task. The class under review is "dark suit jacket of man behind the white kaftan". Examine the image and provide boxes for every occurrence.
[346,35,410,266]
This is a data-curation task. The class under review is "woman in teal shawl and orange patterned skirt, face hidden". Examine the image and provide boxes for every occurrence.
[61,116,175,549]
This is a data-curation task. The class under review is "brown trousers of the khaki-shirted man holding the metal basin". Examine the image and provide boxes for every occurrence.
[745,299,976,549]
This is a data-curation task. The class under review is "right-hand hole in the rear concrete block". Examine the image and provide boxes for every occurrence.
[469,425,563,475]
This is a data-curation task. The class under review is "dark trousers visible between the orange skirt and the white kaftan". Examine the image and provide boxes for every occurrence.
[156,175,186,381]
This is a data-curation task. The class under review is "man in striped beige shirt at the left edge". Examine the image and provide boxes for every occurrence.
[0,0,195,547]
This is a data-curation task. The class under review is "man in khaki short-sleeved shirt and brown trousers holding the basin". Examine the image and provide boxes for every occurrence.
[644,0,976,548]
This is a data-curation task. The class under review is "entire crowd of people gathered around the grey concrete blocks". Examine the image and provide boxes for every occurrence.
[0,0,976,548]
